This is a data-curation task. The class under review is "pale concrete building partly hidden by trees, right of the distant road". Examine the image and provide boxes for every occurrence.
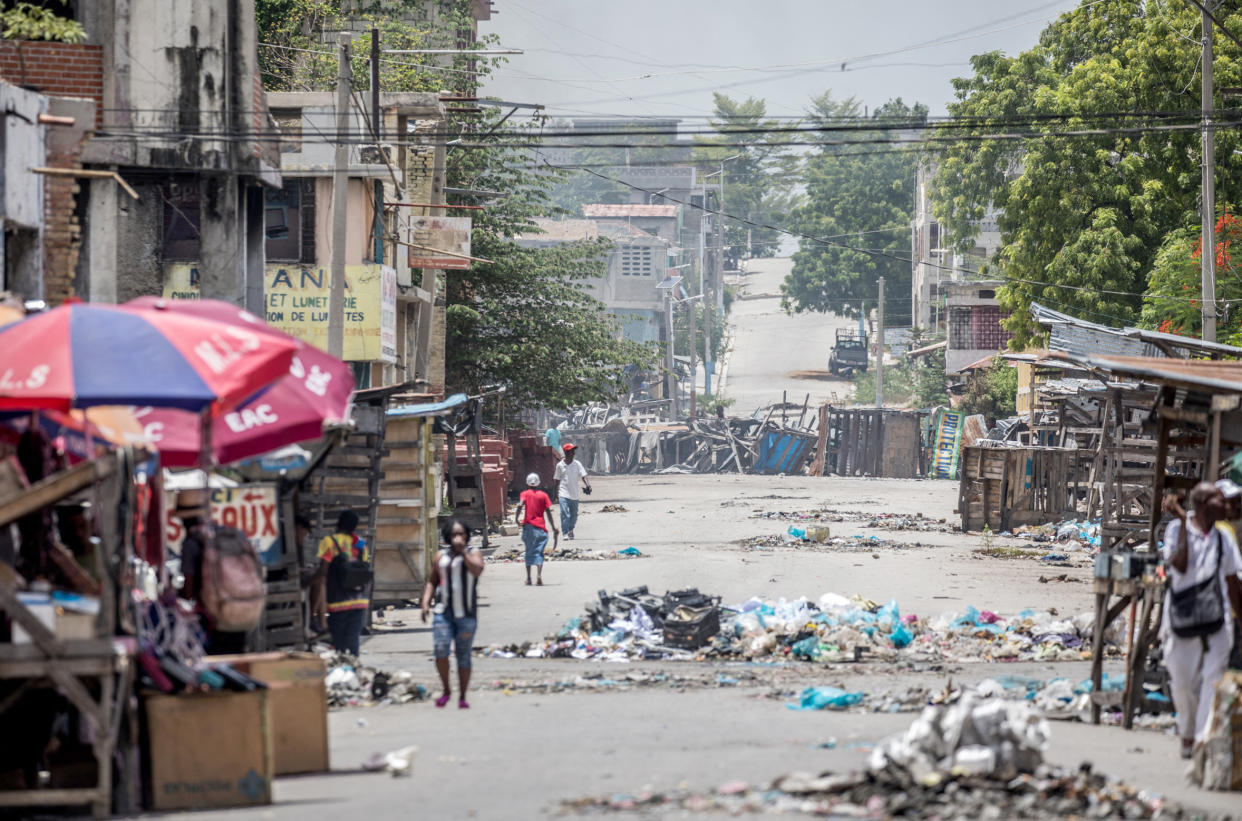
[910,164,1001,333]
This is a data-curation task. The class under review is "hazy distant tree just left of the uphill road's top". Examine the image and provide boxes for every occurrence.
[693,92,796,267]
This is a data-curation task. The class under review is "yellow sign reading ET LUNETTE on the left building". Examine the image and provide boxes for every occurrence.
[164,263,396,363]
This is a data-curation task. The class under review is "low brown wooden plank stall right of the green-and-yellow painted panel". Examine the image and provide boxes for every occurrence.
[958,445,1094,532]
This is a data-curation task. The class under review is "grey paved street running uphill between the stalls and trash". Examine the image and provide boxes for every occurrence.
[172,260,1237,821]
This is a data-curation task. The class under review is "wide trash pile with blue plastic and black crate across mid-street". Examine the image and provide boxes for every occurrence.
[483,587,1124,663]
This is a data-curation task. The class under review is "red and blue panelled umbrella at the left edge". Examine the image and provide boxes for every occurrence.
[0,302,297,411]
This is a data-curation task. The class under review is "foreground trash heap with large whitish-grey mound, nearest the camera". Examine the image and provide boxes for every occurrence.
[561,694,1182,819]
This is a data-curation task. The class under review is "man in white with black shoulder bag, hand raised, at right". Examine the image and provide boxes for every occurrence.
[1161,482,1242,758]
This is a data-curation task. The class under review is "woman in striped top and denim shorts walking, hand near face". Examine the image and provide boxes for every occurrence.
[422,519,483,709]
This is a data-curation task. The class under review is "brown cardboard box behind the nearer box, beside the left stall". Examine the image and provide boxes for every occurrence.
[210,652,329,775]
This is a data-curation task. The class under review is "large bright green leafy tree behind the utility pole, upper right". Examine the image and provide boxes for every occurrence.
[932,0,1242,348]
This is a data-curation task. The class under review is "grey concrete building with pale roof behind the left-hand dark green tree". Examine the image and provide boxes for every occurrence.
[517,219,669,342]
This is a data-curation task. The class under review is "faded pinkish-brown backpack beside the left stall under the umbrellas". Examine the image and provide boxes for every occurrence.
[199,527,267,632]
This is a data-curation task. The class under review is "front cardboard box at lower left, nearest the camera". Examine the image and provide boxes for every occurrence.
[143,691,273,810]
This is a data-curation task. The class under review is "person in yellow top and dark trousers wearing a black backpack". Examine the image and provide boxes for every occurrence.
[312,510,371,656]
